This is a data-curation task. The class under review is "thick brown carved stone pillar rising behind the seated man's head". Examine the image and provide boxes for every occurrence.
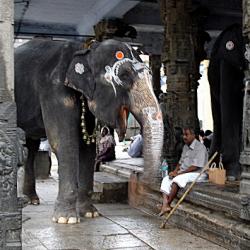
[161,0,199,132]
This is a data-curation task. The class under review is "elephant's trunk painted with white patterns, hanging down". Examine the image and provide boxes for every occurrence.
[130,72,163,183]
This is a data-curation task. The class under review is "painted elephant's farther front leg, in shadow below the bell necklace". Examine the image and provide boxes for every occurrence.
[78,140,99,218]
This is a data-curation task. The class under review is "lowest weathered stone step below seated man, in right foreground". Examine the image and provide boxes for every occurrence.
[165,202,250,250]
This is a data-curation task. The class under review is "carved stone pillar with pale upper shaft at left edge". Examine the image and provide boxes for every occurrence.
[0,0,22,250]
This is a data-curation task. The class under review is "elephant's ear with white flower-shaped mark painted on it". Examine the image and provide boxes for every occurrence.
[65,50,95,100]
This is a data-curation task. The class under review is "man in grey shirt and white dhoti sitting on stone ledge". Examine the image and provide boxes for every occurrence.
[159,127,208,216]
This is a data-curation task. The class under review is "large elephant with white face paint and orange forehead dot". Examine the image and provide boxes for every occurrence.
[15,39,163,224]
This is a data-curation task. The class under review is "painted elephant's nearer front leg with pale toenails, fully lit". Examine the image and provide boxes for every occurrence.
[41,89,80,224]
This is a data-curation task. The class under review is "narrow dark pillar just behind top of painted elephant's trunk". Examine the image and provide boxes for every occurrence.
[149,55,161,100]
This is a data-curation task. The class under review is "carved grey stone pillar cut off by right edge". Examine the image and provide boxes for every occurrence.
[240,0,250,220]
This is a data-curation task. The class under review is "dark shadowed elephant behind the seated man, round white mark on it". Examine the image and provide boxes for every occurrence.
[208,24,246,180]
